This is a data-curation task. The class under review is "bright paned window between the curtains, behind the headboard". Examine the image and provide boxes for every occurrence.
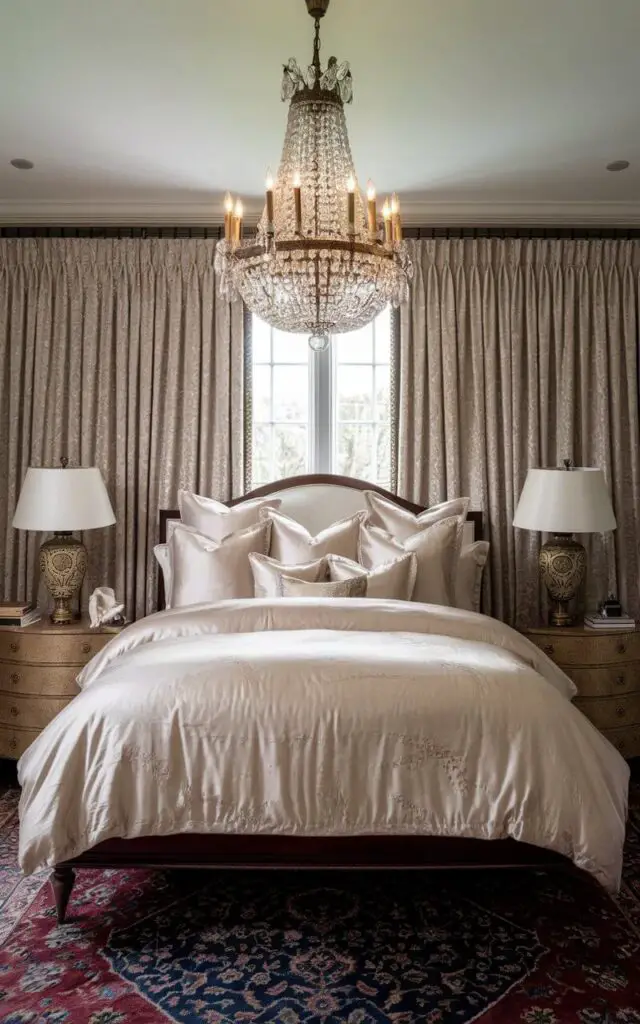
[251,308,392,487]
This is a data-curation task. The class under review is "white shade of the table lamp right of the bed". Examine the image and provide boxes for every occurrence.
[513,466,615,534]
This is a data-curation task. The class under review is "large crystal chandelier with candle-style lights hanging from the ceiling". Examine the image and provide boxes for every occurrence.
[216,0,413,349]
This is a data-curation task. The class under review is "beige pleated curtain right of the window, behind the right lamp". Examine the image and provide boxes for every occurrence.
[397,239,640,625]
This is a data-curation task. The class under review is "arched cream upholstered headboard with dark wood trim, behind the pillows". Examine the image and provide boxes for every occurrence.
[158,473,482,608]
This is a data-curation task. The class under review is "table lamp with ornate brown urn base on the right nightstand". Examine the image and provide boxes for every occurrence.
[513,460,615,626]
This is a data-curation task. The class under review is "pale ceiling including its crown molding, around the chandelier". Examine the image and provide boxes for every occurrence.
[0,0,640,225]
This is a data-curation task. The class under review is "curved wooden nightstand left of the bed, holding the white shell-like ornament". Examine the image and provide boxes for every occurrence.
[0,617,114,759]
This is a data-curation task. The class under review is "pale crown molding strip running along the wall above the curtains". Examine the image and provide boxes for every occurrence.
[0,199,640,227]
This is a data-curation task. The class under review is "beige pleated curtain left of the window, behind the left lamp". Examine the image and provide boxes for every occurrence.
[0,239,245,615]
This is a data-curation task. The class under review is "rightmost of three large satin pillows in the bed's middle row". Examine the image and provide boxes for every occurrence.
[357,515,460,606]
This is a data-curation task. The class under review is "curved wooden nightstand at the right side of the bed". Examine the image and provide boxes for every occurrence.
[522,626,640,758]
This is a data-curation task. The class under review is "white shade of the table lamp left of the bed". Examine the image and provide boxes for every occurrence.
[13,466,116,532]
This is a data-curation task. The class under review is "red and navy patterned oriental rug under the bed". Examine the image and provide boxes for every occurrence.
[0,784,640,1024]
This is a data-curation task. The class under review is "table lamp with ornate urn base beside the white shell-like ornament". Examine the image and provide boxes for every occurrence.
[13,459,116,626]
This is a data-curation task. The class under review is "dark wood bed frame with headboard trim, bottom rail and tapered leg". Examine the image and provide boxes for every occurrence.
[51,475,577,924]
